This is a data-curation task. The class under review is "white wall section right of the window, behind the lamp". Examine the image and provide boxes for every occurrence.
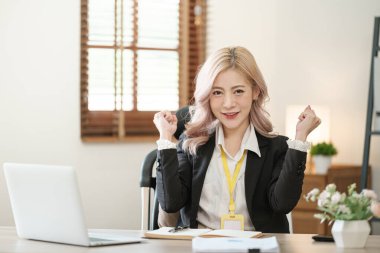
[208,0,380,233]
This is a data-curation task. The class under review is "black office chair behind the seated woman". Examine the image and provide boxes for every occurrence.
[140,106,190,230]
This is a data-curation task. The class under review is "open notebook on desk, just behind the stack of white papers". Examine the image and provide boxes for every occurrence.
[144,227,262,240]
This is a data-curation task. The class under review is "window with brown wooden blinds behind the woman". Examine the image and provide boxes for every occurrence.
[80,0,206,141]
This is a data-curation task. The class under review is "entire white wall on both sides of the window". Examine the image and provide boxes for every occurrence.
[0,0,380,231]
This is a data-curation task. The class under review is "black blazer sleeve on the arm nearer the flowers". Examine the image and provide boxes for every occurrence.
[268,136,307,213]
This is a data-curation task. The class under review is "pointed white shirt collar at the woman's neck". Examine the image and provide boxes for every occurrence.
[215,124,261,157]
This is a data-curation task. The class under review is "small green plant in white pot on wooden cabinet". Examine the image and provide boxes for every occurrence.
[310,142,338,174]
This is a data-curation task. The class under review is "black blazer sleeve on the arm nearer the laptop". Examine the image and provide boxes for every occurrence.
[156,137,192,213]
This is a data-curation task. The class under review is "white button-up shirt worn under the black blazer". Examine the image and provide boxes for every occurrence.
[197,125,261,230]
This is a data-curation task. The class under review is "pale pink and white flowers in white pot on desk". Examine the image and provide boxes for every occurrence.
[304,184,380,248]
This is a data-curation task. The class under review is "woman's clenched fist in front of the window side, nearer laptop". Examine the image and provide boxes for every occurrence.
[153,111,178,141]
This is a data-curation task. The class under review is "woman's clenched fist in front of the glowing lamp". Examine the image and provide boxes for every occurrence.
[296,105,321,141]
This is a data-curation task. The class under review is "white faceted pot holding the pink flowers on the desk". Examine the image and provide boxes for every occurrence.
[331,220,371,248]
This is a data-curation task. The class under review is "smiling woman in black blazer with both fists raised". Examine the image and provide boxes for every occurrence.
[153,47,320,233]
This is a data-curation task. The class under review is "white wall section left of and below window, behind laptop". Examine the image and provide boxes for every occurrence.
[0,0,154,229]
